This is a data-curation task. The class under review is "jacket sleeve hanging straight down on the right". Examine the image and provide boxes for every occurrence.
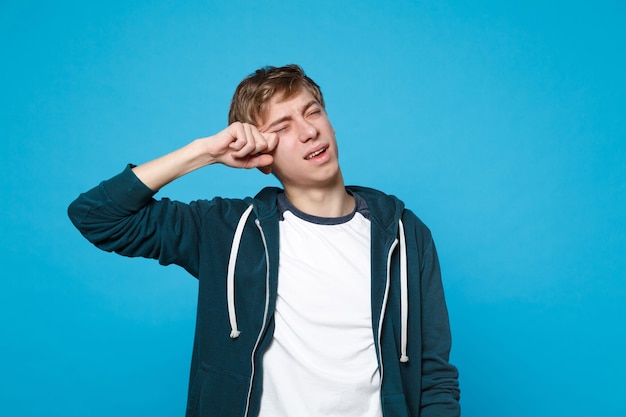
[414,213,460,417]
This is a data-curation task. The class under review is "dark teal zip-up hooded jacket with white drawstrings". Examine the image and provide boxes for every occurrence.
[68,166,460,417]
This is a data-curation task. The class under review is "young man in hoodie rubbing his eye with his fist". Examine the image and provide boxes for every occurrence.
[69,65,460,417]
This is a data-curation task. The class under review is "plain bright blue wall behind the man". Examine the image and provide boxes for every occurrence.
[0,0,626,417]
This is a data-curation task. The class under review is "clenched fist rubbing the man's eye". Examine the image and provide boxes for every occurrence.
[201,122,278,174]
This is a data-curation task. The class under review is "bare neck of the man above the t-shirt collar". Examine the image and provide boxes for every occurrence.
[285,175,355,217]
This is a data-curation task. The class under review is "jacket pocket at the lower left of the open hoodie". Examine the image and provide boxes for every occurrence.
[186,363,250,417]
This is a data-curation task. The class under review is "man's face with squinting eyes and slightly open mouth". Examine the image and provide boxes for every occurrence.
[259,88,343,188]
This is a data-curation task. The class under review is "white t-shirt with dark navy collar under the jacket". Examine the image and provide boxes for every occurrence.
[260,195,382,417]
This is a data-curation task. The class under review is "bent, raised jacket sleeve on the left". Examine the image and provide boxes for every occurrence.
[68,165,208,277]
